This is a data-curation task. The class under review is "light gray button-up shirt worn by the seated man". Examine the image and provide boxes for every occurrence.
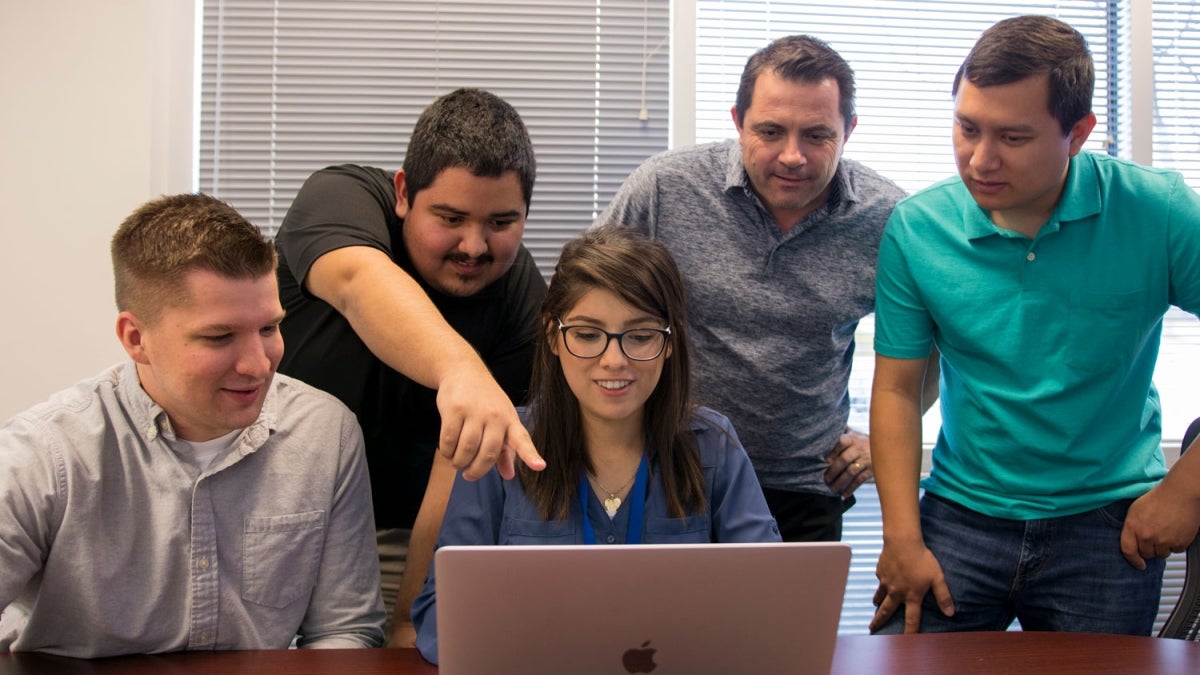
[0,362,385,658]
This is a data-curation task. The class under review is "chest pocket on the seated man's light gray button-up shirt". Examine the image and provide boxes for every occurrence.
[241,510,325,609]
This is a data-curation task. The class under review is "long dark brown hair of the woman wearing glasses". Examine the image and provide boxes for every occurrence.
[517,225,706,520]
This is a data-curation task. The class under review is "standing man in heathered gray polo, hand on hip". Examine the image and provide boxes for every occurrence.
[598,36,936,540]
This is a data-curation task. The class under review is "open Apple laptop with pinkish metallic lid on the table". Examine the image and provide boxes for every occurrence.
[434,543,850,675]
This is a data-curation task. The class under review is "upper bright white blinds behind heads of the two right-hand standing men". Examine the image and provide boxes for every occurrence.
[696,0,1115,192]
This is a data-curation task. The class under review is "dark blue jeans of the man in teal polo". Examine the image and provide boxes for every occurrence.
[876,492,1166,635]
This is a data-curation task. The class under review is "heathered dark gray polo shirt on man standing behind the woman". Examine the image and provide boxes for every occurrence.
[596,139,905,495]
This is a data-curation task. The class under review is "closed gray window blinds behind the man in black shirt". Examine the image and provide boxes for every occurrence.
[199,0,668,275]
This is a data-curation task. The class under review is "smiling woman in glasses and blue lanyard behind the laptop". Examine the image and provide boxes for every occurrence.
[412,226,780,663]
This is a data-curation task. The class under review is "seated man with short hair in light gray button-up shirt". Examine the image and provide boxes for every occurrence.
[0,195,384,657]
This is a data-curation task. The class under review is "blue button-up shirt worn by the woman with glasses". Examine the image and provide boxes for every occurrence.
[412,408,780,663]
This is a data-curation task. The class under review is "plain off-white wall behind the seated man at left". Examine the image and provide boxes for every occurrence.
[0,0,194,420]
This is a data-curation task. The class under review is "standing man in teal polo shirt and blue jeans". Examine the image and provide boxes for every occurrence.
[871,17,1200,634]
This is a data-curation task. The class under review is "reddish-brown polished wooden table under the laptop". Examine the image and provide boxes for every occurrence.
[0,632,1200,675]
